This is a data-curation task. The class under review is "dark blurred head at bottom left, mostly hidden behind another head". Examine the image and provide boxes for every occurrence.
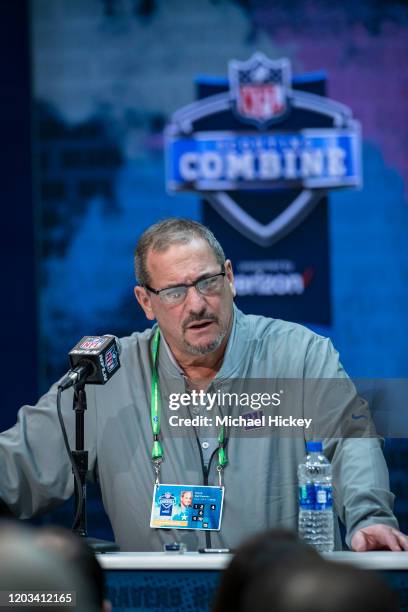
[36,527,112,612]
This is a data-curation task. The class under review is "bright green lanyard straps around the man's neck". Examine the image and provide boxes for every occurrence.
[150,328,228,485]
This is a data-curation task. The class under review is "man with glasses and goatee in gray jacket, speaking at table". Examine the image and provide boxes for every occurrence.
[0,219,408,550]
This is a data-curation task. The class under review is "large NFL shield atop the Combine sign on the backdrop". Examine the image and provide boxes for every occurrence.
[229,53,291,127]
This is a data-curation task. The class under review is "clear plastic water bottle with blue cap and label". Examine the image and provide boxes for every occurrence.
[298,442,334,552]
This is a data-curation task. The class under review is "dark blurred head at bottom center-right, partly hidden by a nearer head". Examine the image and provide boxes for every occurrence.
[213,529,323,612]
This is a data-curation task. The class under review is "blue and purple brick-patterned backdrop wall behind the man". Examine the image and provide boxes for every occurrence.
[26,0,408,533]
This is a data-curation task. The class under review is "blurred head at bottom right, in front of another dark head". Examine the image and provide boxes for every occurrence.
[240,559,399,612]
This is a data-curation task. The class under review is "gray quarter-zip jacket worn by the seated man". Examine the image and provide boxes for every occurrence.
[0,308,398,551]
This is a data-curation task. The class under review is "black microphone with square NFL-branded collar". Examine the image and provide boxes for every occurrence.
[58,335,121,391]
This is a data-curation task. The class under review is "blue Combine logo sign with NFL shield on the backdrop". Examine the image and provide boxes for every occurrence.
[165,53,361,247]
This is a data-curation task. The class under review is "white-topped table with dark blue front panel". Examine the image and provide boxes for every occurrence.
[98,552,408,612]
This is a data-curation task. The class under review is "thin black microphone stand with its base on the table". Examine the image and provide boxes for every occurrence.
[71,381,119,552]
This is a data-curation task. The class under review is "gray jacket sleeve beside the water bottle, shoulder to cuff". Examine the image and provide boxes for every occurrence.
[305,336,398,546]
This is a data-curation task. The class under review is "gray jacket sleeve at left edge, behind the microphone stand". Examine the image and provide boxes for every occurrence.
[0,383,96,518]
